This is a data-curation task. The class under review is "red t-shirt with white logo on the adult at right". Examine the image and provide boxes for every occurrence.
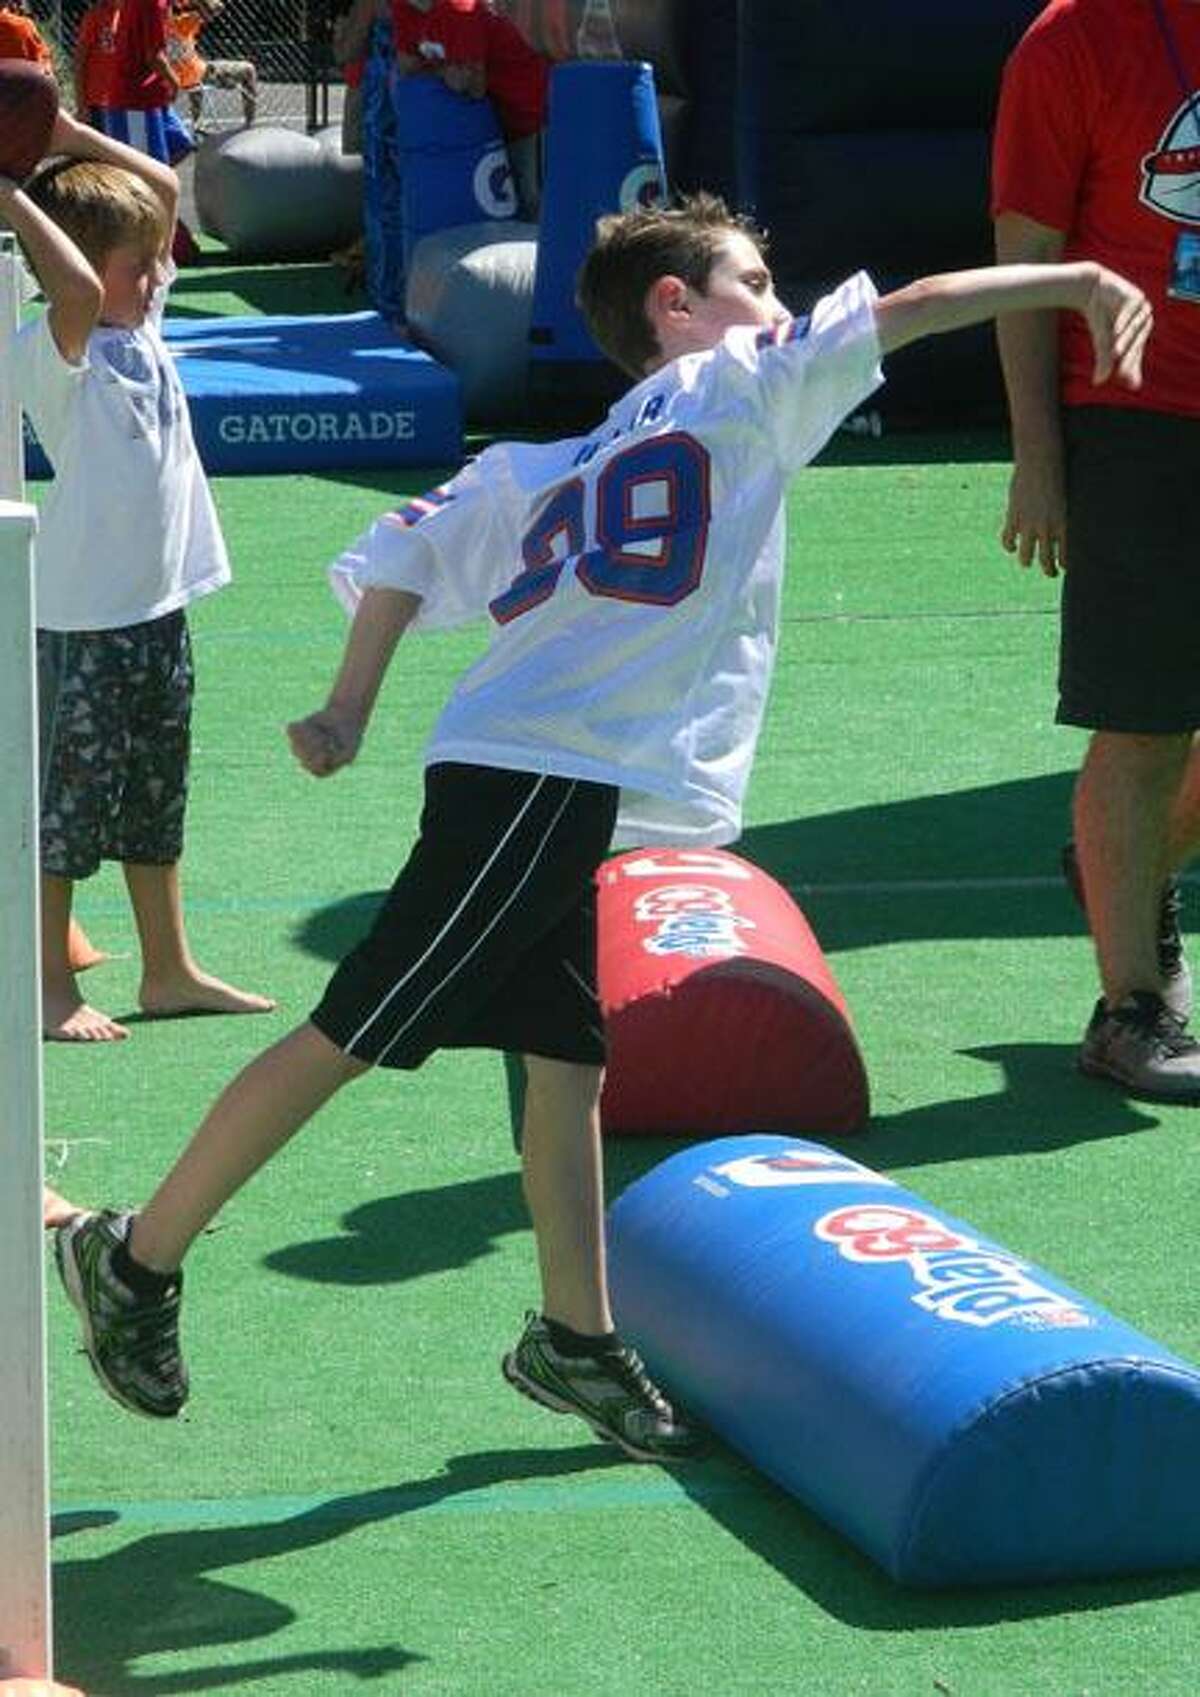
[991,0,1200,416]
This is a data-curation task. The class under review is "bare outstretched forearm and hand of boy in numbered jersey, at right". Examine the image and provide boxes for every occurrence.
[876,260,1154,389]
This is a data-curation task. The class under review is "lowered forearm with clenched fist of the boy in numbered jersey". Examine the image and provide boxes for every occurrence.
[287,589,421,777]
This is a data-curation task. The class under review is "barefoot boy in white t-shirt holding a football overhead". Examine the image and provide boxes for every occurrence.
[0,112,273,1042]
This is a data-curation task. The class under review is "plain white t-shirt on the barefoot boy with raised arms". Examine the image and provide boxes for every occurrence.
[15,288,229,631]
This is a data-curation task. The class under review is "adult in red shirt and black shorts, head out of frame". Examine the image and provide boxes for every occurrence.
[991,0,1200,1101]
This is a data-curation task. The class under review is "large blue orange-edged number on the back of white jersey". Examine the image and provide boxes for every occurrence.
[491,434,711,624]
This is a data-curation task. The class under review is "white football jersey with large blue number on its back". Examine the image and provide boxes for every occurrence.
[331,273,883,847]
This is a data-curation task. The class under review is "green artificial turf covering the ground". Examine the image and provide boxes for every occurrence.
[46,427,1200,1697]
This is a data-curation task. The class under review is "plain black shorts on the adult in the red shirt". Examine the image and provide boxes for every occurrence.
[1057,407,1200,735]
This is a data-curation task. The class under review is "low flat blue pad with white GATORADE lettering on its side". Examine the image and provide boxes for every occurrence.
[27,312,463,477]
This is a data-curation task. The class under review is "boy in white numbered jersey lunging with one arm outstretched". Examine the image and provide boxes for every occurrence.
[58,197,1151,1459]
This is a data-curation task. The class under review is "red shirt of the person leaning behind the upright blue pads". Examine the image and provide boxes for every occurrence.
[392,0,548,139]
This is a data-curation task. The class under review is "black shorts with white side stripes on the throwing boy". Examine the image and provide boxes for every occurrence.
[312,764,618,1067]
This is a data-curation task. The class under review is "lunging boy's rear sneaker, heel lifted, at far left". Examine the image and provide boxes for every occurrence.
[54,1210,187,1419]
